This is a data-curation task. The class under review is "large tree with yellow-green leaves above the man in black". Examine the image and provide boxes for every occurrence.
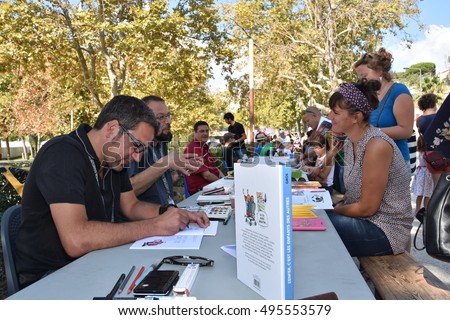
[0,0,234,146]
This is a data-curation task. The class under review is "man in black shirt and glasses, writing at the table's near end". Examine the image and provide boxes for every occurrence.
[15,96,209,288]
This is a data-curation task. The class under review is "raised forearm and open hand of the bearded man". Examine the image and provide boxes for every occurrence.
[130,151,203,196]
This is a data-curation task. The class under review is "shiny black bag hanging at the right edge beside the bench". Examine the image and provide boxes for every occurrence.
[414,172,450,262]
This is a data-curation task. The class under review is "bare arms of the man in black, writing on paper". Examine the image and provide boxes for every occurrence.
[50,191,209,258]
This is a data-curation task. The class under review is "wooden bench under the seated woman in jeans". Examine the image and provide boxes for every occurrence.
[358,252,450,300]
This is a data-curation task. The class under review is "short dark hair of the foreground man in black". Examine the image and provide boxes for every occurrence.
[94,95,159,132]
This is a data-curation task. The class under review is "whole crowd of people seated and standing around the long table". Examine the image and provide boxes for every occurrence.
[15,48,450,287]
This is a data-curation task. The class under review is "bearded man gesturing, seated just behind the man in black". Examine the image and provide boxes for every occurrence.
[128,96,202,205]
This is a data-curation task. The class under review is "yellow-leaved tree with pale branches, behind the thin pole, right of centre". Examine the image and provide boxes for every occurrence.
[224,0,419,130]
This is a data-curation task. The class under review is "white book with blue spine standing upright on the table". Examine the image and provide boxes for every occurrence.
[234,164,294,300]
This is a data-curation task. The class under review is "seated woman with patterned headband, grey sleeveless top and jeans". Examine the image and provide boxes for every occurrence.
[328,80,414,256]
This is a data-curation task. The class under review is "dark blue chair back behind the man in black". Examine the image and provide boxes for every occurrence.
[0,204,22,296]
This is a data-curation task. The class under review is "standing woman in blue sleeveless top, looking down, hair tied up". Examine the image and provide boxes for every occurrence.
[354,48,414,168]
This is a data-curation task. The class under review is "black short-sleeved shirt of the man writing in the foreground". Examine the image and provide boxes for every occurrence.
[15,125,132,287]
